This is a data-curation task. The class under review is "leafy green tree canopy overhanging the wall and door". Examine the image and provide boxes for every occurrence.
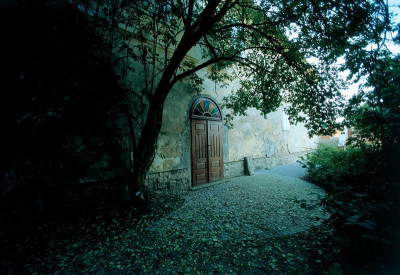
[79,0,390,134]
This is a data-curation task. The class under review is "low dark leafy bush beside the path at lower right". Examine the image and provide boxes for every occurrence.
[302,145,400,273]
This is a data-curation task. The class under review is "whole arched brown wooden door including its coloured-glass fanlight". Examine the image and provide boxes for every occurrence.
[190,97,224,186]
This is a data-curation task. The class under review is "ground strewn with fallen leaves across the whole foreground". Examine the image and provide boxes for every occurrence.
[0,176,338,274]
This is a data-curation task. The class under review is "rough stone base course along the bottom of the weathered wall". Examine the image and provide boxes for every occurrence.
[146,152,307,193]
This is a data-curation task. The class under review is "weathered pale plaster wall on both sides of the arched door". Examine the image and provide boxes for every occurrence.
[144,66,318,191]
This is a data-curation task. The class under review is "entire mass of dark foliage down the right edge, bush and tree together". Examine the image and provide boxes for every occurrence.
[303,3,400,273]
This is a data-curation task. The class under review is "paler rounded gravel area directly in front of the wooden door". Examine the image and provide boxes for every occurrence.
[149,173,328,241]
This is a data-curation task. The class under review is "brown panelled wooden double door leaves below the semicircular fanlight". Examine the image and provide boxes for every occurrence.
[191,119,224,186]
